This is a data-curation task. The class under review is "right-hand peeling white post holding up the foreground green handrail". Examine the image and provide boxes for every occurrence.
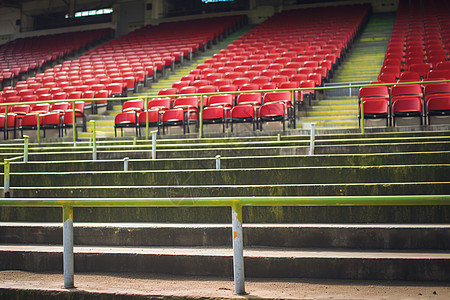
[232,203,245,295]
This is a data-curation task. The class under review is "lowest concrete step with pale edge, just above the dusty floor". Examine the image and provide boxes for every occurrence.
[0,245,450,282]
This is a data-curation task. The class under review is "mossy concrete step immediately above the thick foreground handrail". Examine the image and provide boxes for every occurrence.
[7,182,450,198]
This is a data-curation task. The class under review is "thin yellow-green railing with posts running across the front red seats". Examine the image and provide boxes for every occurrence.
[0,80,450,145]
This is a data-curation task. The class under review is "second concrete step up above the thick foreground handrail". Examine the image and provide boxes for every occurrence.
[1,164,450,187]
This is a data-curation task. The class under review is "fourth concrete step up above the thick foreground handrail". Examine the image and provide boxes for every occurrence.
[0,139,450,161]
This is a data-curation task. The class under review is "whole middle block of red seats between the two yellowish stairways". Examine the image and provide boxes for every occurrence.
[124,5,369,134]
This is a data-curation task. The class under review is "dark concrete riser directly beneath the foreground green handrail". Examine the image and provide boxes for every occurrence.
[0,205,450,224]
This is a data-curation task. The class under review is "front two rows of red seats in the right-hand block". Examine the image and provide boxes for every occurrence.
[359,81,450,126]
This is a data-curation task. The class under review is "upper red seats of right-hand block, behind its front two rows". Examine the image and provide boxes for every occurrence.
[378,0,450,82]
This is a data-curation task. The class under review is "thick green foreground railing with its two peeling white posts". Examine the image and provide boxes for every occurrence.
[0,195,450,294]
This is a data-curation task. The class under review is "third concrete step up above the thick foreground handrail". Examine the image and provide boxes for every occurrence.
[7,151,450,173]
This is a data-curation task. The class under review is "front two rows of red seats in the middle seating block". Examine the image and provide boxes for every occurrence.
[115,91,295,135]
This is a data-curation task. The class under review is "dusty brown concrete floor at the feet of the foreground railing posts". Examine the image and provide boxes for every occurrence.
[0,271,450,300]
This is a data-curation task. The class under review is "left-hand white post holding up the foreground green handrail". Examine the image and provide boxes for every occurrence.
[63,205,74,289]
